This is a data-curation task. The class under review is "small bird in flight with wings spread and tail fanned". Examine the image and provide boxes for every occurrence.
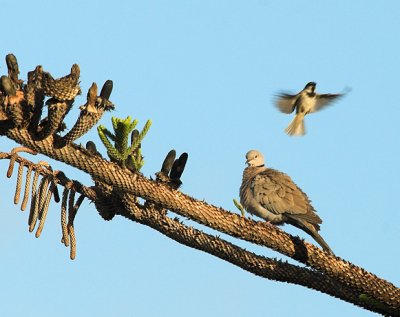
[276,82,344,136]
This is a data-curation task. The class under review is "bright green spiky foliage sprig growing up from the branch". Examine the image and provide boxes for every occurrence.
[97,116,151,171]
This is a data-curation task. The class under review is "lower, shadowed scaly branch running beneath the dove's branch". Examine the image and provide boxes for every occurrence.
[116,194,400,316]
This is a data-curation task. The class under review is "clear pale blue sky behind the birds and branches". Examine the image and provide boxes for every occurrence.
[0,0,400,317]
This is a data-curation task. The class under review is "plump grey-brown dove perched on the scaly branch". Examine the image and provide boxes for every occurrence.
[239,150,334,254]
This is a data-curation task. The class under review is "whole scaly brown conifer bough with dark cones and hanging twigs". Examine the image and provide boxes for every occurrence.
[0,57,400,316]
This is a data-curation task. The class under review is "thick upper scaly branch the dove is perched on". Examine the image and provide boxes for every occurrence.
[1,129,400,308]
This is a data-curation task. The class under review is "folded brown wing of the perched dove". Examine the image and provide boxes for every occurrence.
[252,168,322,225]
